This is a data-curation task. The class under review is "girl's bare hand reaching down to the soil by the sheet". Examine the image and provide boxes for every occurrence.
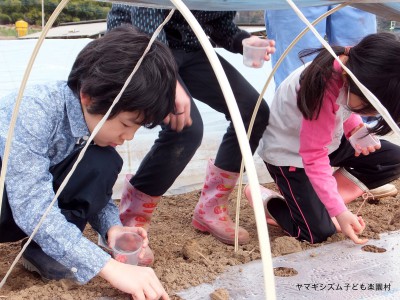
[336,210,368,244]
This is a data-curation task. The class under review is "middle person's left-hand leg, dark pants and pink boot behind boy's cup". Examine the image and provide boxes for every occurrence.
[119,70,203,260]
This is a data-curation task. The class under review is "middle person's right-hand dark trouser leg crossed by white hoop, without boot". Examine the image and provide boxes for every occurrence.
[180,51,269,173]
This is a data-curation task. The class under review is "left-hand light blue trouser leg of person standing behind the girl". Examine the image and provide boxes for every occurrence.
[265,6,328,88]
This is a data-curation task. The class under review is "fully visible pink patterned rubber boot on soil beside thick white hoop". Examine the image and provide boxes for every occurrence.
[192,159,250,245]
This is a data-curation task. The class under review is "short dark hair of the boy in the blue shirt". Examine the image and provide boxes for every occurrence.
[68,25,177,128]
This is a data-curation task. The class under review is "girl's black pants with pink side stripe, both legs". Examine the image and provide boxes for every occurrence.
[266,138,400,243]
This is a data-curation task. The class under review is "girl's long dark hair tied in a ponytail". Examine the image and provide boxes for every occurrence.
[297,32,400,135]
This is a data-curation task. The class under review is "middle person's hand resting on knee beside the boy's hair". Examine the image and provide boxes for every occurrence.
[164,81,192,132]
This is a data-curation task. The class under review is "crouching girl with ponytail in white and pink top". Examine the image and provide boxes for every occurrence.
[246,33,400,244]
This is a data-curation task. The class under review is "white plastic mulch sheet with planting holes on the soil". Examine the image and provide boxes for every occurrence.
[178,231,400,300]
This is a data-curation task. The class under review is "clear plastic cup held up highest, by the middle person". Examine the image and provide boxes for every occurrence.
[242,39,269,68]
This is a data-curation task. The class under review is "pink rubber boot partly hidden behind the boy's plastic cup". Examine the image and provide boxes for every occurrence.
[119,174,161,266]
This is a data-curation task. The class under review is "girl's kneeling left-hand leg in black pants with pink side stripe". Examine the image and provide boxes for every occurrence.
[266,164,336,243]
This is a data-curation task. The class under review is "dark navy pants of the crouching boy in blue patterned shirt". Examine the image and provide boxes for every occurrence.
[0,145,122,242]
